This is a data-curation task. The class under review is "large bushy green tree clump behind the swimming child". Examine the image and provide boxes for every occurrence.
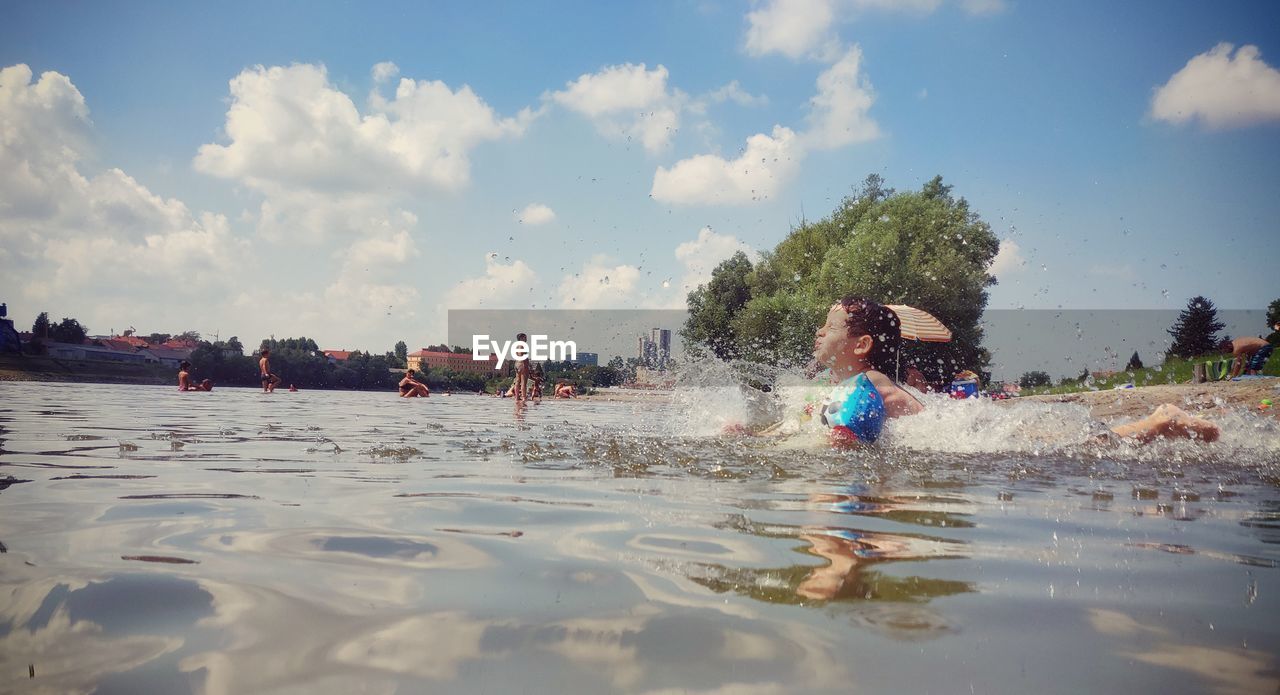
[681,175,1000,380]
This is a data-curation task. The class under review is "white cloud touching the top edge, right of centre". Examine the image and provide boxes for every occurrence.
[746,0,836,60]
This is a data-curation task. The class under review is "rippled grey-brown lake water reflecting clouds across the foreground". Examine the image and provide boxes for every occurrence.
[0,383,1280,694]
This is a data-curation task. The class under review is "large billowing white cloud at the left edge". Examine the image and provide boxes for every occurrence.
[0,65,250,325]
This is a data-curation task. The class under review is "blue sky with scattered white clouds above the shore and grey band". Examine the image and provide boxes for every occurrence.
[0,0,1280,352]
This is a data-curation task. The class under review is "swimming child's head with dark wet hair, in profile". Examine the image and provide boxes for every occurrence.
[813,296,902,372]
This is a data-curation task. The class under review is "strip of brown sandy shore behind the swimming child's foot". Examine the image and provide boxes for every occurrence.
[1002,379,1280,422]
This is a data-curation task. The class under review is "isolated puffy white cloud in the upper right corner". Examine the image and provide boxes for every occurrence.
[1149,44,1280,129]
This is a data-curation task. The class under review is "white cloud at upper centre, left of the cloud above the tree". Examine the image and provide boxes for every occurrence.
[547,63,687,152]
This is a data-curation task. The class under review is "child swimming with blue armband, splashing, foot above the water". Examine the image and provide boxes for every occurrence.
[757,297,1220,448]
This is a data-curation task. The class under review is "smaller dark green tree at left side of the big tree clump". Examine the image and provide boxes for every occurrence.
[686,251,751,360]
